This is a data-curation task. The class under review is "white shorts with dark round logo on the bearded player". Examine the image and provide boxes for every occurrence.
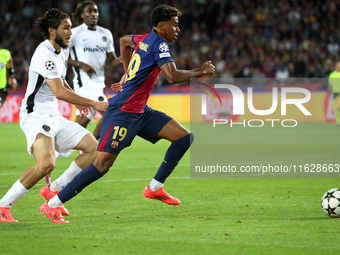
[20,112,90,158]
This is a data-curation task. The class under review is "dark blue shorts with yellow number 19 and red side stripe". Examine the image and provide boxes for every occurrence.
[98,105,172,154]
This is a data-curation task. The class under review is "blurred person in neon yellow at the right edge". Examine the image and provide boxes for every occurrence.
[328,62,340,125]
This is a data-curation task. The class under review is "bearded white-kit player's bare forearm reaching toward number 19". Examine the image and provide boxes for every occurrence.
[46,78,108,111]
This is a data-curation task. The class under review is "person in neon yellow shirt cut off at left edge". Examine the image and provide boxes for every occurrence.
[0,49,18,109]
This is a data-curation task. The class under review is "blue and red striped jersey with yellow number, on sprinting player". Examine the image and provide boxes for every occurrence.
[109,30,174,113]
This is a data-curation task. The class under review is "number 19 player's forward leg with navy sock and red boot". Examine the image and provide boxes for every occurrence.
[143,119,193,205]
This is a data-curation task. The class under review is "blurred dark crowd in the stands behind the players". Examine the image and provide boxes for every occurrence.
[0,0,340,86]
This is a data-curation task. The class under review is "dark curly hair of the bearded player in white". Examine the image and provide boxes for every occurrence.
[35,8,70,39]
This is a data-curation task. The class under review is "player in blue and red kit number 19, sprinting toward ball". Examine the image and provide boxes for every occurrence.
[41,5,215,223]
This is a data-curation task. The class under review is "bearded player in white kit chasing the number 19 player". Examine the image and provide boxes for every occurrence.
[0,9,107,222]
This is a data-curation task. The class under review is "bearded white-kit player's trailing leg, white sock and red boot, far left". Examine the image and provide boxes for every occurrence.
[0,133,55,222]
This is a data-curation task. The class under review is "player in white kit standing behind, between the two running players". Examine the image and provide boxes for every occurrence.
[68,1,120,140]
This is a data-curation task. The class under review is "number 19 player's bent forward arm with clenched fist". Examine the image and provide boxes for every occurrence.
[161,61,215,83]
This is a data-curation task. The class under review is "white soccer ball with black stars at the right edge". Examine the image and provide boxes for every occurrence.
[321,188,340,218]
